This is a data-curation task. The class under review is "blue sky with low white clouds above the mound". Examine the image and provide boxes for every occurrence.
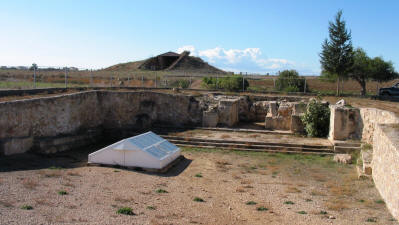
[0,0,399,75]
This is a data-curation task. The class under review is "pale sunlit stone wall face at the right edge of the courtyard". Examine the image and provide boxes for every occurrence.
[371,124,399,220]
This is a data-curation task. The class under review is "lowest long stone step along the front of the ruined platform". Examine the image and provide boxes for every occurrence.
[161,135,333,151]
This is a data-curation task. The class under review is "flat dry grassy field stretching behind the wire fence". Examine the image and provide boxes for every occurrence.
[0,69,399,95]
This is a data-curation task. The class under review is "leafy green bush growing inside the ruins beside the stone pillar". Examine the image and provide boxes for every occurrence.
[301,100,330,137]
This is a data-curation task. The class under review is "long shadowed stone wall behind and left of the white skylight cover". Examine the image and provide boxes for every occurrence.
[0,91,202,155]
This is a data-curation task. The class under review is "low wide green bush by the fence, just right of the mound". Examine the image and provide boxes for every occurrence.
[202,75,249,91]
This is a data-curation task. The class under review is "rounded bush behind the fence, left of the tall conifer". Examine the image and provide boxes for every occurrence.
[276,70,307,92]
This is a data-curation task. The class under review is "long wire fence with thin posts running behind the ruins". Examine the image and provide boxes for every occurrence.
[0,66,398,95]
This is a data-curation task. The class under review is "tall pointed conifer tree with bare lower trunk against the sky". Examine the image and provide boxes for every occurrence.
[320,10,353,95]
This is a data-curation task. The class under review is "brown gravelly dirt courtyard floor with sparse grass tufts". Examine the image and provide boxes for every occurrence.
[0,148,397,225]
